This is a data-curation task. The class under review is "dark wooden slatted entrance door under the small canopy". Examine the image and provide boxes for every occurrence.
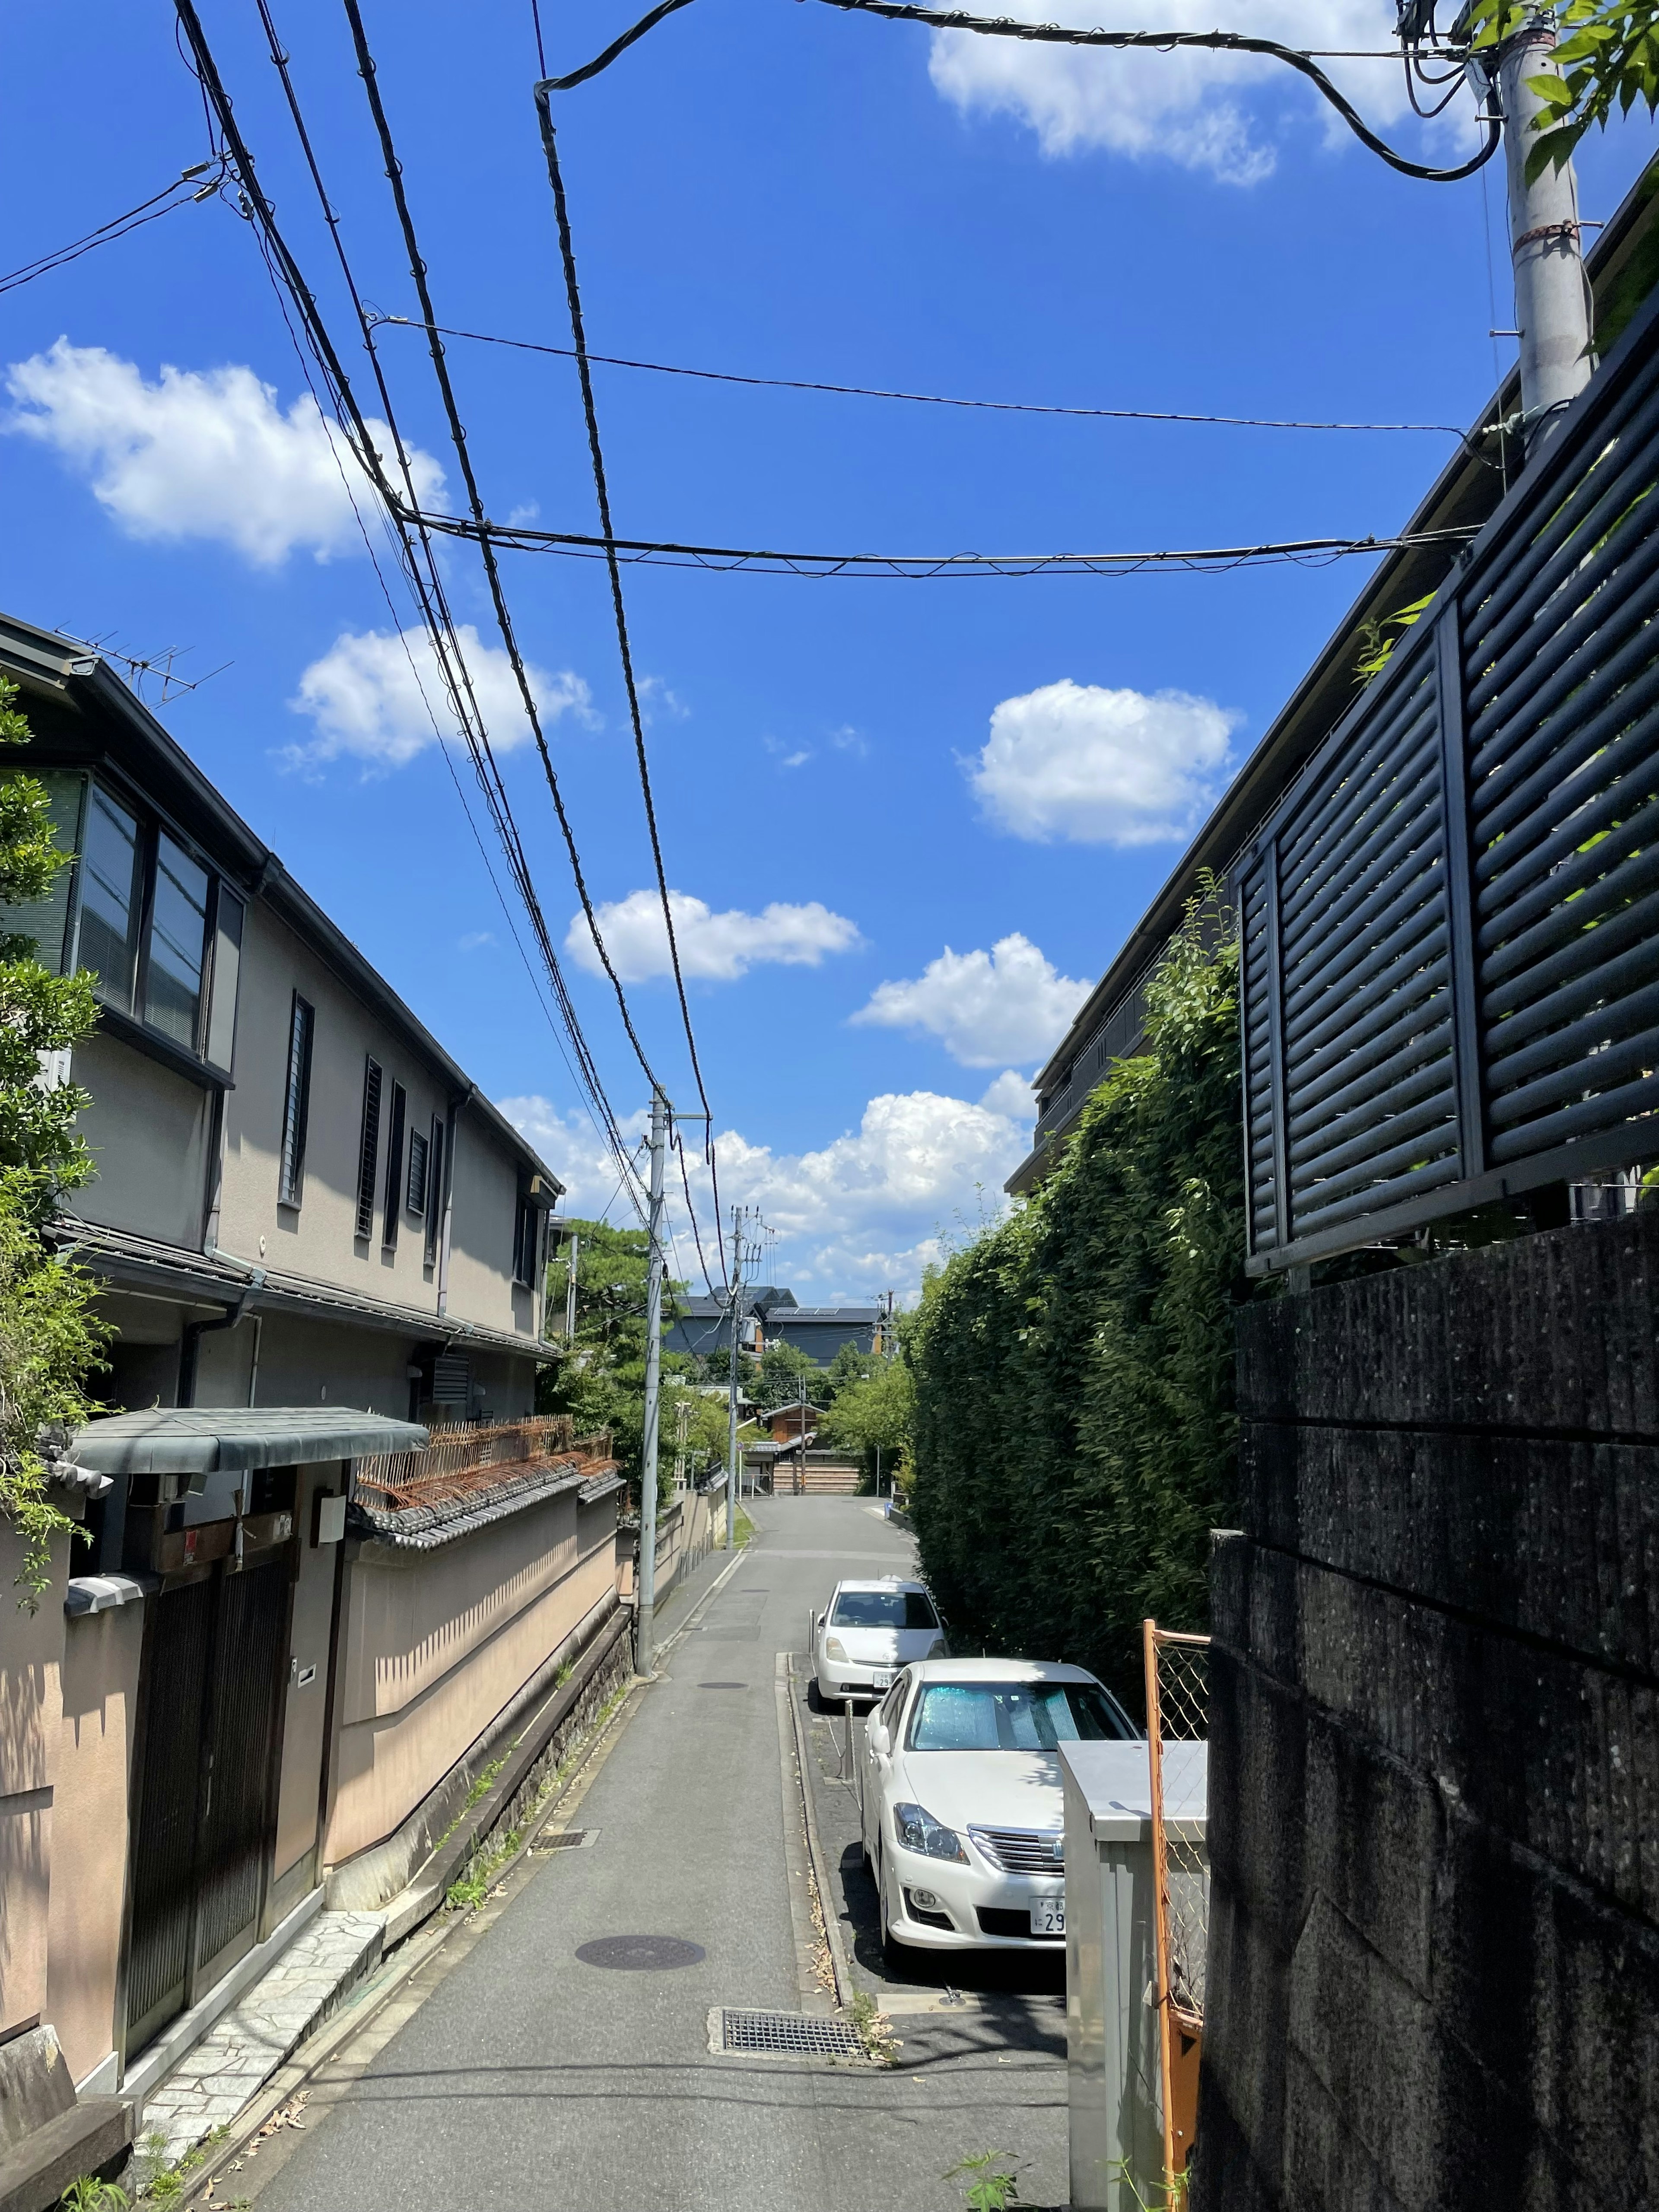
[126,1562,288,2059]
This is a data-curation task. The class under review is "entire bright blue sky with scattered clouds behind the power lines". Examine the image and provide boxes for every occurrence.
[0,0,1655,1298]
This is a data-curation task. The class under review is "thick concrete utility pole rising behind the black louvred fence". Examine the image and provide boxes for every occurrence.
[1497,11,1590,451]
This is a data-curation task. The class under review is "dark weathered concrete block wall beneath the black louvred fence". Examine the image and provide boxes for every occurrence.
[1195,1212,1659,2212]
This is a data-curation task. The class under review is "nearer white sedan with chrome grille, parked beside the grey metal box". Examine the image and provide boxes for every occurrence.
[863,1659,1139,1960]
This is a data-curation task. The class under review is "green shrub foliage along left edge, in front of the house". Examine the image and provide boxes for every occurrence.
[0,683,108,1608]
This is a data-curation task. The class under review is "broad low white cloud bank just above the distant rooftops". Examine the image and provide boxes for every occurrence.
[500,1075,1033,1305]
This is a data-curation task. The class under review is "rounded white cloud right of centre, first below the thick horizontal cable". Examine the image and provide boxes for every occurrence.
[971,677,1243,845]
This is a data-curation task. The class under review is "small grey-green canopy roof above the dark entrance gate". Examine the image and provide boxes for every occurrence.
[69,1405,427,1475]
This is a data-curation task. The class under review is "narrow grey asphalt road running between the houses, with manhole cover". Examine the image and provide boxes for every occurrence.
[240,1497,1066,2212]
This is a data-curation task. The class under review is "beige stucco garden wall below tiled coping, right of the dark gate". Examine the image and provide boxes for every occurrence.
[323,1493,615,1865]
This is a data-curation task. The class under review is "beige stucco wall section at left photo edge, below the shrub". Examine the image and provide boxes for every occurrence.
[0,1522,69,2035]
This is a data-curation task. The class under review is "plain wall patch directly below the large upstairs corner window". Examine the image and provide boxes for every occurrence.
[69,1031,213,1250]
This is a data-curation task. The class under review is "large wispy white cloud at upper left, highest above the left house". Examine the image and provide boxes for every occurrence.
[4,338,445,569]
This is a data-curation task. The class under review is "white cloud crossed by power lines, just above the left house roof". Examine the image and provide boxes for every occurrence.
[283,622,593,768]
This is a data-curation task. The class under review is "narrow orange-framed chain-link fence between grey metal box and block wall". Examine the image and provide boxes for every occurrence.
[1141,1621,1210,2183]
